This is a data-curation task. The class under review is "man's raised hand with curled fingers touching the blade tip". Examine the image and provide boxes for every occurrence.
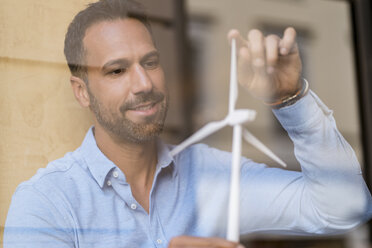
[228,27,302,103]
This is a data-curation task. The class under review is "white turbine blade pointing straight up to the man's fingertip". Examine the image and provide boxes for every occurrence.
[229,39,238,113]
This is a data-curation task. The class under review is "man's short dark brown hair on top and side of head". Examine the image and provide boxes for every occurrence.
[64,0,151,83]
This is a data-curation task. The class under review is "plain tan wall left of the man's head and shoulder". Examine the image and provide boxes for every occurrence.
[0,0,96,244]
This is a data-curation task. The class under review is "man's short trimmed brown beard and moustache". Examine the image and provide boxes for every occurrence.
[87,86,168,143]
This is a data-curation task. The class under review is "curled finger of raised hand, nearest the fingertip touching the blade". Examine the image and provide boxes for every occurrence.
[248,29,266,70]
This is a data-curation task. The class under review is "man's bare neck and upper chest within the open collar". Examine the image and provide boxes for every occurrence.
[94,127,157,212]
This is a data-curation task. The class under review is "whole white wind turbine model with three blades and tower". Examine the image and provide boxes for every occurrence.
[170,38,286,242]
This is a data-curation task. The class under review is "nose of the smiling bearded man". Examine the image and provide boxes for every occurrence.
[132,65,153,95]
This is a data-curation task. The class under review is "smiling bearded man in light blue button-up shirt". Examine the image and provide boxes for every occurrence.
[4,0,372,248]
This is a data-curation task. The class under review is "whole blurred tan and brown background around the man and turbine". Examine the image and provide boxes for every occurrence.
[0,0,372,248]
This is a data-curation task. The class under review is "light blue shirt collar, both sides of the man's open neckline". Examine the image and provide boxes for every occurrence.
[80,127,176,188]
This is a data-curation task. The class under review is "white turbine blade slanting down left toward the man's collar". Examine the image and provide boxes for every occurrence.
[170,119,228,156]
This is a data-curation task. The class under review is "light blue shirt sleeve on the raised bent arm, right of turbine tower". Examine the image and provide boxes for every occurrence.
[241,91,372,235]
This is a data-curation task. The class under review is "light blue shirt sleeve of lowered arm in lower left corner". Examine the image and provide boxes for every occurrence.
[4,185,75,248]
